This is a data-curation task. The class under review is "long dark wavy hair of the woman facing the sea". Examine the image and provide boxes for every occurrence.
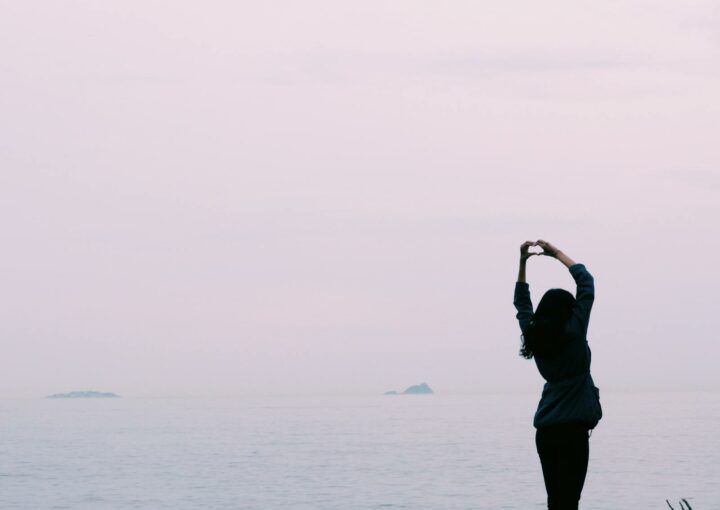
[520,289,575,359]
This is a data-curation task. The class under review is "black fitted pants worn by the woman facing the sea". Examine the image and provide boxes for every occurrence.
[535,423,589,510]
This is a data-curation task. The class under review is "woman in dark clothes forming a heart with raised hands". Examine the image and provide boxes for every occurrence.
[513,240,602,510]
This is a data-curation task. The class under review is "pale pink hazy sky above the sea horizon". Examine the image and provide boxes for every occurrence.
[0,0,720,398]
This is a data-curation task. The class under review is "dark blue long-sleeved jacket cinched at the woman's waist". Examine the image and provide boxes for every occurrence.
[513,264,602,428]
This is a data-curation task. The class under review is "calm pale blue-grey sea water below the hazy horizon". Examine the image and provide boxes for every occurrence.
[0,393,720,510]
